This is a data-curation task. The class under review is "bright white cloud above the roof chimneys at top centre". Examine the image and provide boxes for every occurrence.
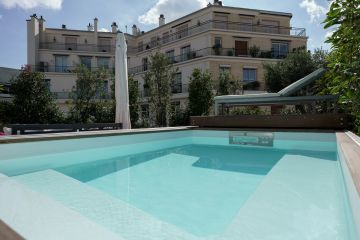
[138,0,208,24]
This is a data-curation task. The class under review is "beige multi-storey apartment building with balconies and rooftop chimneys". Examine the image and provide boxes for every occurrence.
[27,0,307,111]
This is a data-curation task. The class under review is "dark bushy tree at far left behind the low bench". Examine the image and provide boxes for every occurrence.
[6,67,63,124]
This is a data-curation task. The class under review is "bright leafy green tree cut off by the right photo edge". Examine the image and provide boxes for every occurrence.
[324,0,360,133]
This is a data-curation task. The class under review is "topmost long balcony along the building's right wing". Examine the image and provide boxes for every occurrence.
[133,20,306,53]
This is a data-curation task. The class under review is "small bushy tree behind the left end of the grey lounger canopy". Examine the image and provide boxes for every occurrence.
[218,71,242,95]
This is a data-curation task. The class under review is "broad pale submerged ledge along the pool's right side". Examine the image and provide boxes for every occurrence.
[219,153,357,240]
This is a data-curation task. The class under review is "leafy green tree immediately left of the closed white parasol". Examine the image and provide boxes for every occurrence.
[69,65,115,123]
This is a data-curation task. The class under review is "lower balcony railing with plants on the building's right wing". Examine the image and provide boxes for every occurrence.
[129,48,288,74]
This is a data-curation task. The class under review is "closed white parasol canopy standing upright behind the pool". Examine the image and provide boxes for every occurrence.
[115,32,131,129]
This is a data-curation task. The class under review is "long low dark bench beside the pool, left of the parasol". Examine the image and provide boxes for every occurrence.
[6,123,122,135]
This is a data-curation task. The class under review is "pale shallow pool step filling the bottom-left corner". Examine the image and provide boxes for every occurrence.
[0,174,123,240]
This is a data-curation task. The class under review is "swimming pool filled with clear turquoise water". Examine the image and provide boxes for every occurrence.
[0,130,358,240]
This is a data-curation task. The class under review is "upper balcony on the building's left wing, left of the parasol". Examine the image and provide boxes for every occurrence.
[39,42,115,53]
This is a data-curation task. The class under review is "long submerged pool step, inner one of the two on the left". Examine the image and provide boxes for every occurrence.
[13,170,197,240]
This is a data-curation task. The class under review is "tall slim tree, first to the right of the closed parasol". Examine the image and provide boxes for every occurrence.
[144,52,176,127]
